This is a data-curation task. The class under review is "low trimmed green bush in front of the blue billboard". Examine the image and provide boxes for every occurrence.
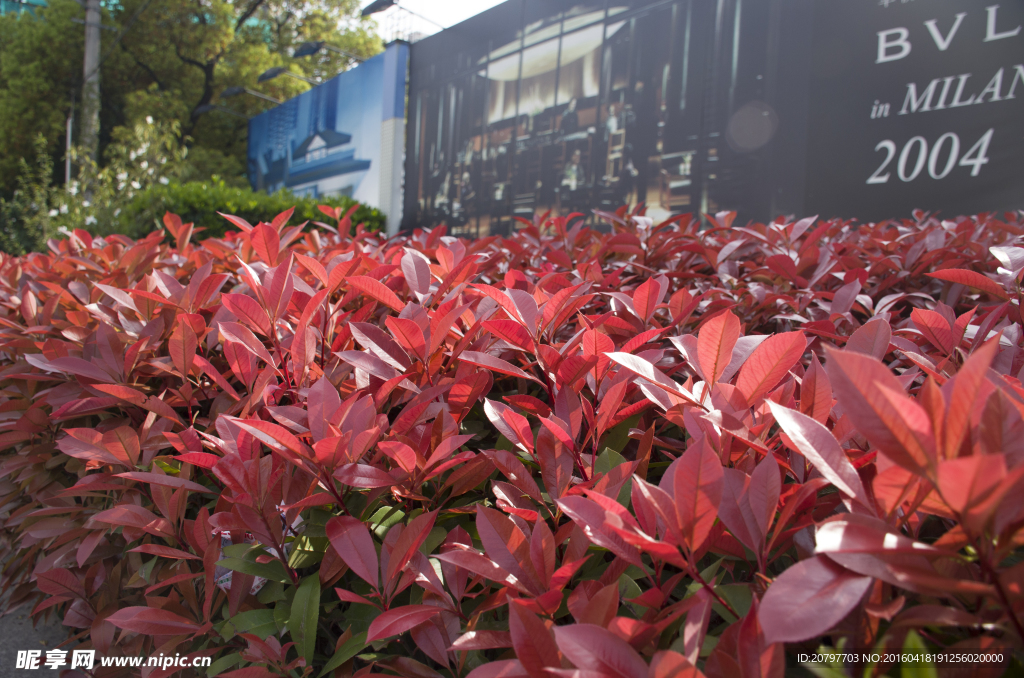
[111,181,384,239]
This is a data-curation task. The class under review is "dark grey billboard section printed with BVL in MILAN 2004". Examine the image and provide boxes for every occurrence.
[807,0,1024,218]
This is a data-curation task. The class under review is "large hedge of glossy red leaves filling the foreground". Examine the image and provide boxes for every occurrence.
[0,209,1024,678]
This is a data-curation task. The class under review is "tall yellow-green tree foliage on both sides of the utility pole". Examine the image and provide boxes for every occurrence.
[0,0,382,195]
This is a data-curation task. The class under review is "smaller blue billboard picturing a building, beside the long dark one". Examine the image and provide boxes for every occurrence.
[249,42,409,233]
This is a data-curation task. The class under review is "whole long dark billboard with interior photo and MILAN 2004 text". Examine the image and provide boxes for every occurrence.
[403,0,1024,236]
